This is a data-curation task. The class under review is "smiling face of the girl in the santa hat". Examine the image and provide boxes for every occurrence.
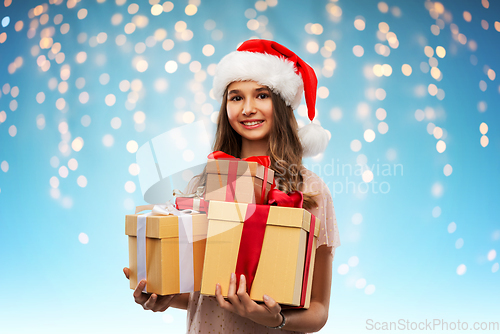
[226,81,273,141]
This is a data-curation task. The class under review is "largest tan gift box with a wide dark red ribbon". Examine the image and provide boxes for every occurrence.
[201,190,319,308]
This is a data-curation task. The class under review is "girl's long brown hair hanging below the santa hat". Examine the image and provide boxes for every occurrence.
[193,89,317,209]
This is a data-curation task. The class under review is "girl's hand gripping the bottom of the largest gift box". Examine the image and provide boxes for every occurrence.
[215,273,283,327]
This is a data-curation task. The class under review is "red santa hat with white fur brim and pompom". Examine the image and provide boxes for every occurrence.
[213,39,329,156]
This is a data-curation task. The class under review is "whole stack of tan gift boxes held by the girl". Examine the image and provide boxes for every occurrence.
[126,152,319,308]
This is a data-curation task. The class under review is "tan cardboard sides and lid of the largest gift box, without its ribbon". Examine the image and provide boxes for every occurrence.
[201,201,320,308]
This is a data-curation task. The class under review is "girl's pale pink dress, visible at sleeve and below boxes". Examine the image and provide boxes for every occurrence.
[187,171,340,334]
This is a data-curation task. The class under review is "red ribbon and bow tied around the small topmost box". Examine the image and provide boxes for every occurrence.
[208,151,274,204]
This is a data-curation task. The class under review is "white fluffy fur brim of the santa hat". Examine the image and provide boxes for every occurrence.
[213,51,304,110]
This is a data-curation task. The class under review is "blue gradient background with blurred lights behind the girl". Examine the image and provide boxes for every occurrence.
[0,0,500,333]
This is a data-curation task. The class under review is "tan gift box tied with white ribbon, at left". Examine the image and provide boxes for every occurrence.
[125,204,208,295]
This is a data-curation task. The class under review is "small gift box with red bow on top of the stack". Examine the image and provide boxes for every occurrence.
[205,151,274,204]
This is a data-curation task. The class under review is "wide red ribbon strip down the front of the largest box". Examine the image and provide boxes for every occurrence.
[235,204,271,294]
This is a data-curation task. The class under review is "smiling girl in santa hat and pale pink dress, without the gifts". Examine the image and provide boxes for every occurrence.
[124,40,340,333]
